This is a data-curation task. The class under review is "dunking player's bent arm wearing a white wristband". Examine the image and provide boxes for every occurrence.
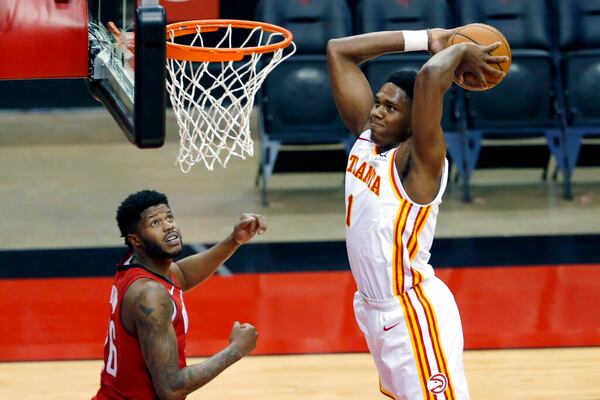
[327,31,428,136]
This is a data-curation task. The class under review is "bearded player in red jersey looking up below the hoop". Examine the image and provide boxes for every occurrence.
[94,190,266,400]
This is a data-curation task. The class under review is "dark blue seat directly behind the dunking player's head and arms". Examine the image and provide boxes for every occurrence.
[357,0,466,197]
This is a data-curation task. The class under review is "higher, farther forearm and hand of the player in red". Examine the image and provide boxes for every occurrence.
[171,214,267,291]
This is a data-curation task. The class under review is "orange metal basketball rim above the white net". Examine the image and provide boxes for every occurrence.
[167,19,294,62]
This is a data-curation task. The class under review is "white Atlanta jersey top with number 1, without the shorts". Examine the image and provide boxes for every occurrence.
[346,130,448,299]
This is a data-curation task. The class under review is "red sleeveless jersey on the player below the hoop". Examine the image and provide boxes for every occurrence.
[93,257,188,400]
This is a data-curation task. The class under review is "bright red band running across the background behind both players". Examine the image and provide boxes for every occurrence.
[0,265,600,361]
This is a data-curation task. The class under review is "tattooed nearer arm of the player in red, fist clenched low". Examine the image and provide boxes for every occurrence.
[128,281,257,400]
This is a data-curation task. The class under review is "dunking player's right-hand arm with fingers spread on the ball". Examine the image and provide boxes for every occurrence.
[411,38,506,180]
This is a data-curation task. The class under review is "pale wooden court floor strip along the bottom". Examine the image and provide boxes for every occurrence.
[0,348,600,400]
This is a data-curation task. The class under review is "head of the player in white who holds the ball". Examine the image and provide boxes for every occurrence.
[369,71,417,146]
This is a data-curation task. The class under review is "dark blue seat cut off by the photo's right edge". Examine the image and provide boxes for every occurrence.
[554,0,600,181]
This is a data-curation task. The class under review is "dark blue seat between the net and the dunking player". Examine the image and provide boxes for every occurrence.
[256,0,353,205]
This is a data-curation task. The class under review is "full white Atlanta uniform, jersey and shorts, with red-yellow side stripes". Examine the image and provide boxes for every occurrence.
[346,131,469,400]
